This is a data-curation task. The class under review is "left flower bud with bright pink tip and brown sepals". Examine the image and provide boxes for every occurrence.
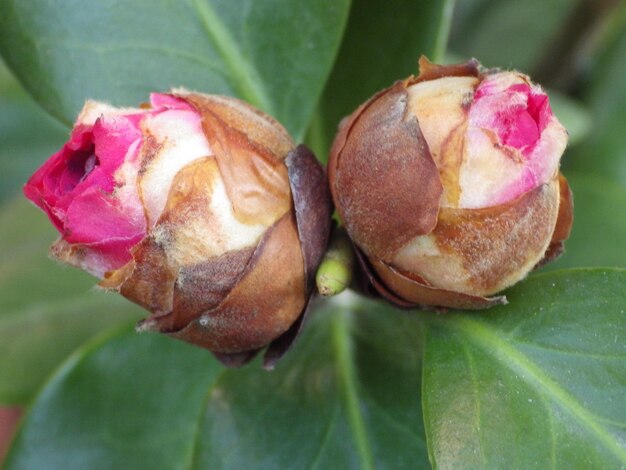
[24,90,330,365]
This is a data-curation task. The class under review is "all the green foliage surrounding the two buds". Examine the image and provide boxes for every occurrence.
[0,0,626,469]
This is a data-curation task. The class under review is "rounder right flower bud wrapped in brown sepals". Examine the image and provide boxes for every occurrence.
[328,57,572,309]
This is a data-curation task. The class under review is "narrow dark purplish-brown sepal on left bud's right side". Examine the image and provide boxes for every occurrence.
[285,145,332,294]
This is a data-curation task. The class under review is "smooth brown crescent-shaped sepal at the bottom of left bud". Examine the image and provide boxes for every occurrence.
[162,213,306,353]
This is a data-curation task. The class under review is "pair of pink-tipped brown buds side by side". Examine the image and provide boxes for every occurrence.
[24,59,572,367]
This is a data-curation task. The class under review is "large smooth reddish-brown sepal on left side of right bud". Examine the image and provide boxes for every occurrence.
[329,82,443,261]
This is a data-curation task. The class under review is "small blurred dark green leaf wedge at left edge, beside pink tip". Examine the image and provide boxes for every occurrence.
[0,62,67,202]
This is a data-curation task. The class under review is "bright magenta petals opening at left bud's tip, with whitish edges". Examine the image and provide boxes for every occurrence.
[24,94,209,277]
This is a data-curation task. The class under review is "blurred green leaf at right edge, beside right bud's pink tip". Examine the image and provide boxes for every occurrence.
[566,28,626,187]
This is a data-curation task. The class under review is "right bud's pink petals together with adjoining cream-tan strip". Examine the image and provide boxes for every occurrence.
[407,64,567,209]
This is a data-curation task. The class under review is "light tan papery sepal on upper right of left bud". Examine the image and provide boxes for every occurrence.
[177,94,294,225]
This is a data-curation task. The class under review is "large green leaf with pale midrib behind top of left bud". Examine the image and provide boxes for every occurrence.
[0,0,349,139]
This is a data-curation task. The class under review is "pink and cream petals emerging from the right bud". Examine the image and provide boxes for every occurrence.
[462,72,567,208]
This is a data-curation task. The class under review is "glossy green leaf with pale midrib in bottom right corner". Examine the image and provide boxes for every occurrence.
[423,269,626,468]
